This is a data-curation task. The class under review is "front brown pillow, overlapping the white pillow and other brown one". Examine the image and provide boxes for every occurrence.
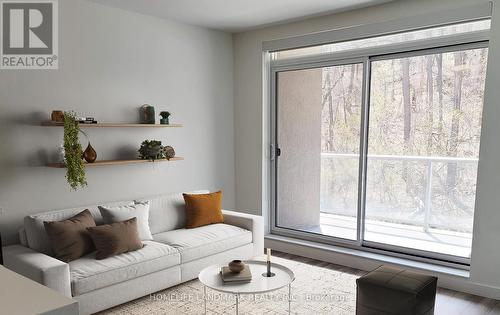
[87,218,143,259]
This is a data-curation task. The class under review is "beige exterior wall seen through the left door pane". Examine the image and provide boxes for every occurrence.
[276,69,323,230]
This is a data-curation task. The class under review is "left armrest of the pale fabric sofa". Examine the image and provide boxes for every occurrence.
[3,245,71,298]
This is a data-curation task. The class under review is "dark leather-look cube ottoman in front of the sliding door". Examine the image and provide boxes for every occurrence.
[356,266,437,315]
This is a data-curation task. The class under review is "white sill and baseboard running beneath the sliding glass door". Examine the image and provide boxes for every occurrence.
[265,235,500,300]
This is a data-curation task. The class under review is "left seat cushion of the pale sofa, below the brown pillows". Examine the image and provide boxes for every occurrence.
[69,241,180,296]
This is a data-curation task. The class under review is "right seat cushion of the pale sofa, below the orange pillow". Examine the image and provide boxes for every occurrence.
[153,223,252,263]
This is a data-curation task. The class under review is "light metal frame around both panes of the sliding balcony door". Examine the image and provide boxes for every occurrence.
[269,32,489,269]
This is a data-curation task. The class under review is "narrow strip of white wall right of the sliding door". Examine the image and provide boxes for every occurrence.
[471,0,500,292]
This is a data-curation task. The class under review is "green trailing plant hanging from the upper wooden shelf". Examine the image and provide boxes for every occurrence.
[64,112,87,190]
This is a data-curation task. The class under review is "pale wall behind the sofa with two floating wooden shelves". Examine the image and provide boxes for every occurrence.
[0,0,235,243]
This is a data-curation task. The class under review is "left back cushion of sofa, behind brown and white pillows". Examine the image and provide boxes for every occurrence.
[24,201,134,256]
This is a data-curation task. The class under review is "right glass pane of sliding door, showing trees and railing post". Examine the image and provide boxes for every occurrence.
[364,48,487,257]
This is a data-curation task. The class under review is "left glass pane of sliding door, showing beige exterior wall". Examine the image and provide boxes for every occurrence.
[276,63,363,240]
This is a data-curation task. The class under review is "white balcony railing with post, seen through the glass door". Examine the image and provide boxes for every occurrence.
[321,153,478,231]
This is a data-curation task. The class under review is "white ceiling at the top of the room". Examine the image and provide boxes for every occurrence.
[91,0,390,32]
